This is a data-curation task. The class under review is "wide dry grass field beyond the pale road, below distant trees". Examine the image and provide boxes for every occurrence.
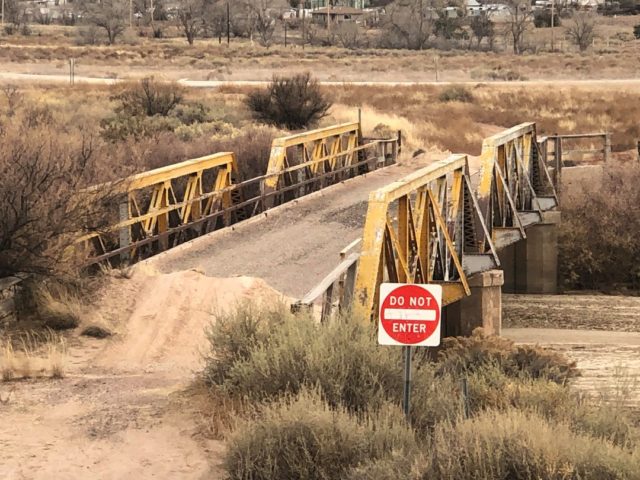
[0,17,640,81]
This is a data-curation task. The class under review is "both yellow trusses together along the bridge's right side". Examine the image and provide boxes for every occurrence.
[354,123,558,318]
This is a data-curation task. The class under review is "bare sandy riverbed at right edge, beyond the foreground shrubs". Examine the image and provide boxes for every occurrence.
[502,294,640,407]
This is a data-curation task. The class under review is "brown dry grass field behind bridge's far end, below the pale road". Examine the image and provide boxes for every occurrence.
[331,84,640,155]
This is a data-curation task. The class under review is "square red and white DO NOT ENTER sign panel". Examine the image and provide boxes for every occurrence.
[378,283,442,347]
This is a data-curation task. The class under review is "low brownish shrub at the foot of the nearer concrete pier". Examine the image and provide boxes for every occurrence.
[438,328,579,384]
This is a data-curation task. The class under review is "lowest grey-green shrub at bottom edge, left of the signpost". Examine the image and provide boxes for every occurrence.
[225,391,416,480]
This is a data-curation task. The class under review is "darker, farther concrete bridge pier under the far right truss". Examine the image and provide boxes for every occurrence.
[498,211,561,293]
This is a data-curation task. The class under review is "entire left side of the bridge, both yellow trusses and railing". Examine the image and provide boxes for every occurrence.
[78,123,401,265]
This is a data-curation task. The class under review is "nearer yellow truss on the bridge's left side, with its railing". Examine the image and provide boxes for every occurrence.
[77,152,237,264]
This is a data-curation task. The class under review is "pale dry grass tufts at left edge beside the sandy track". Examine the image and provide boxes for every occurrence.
[0,330,67,382]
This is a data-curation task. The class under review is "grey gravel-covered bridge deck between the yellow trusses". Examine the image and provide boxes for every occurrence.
[147,157,435,298]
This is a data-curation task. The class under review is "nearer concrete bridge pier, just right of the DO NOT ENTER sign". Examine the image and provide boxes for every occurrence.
[442,270,503,337]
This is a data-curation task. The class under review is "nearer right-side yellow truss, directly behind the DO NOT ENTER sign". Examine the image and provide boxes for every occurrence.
[353,155,499,318]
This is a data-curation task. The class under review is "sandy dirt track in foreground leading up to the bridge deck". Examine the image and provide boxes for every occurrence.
[0,271,281,480]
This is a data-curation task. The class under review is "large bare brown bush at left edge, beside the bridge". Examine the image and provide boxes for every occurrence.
[0,121,121,279]
